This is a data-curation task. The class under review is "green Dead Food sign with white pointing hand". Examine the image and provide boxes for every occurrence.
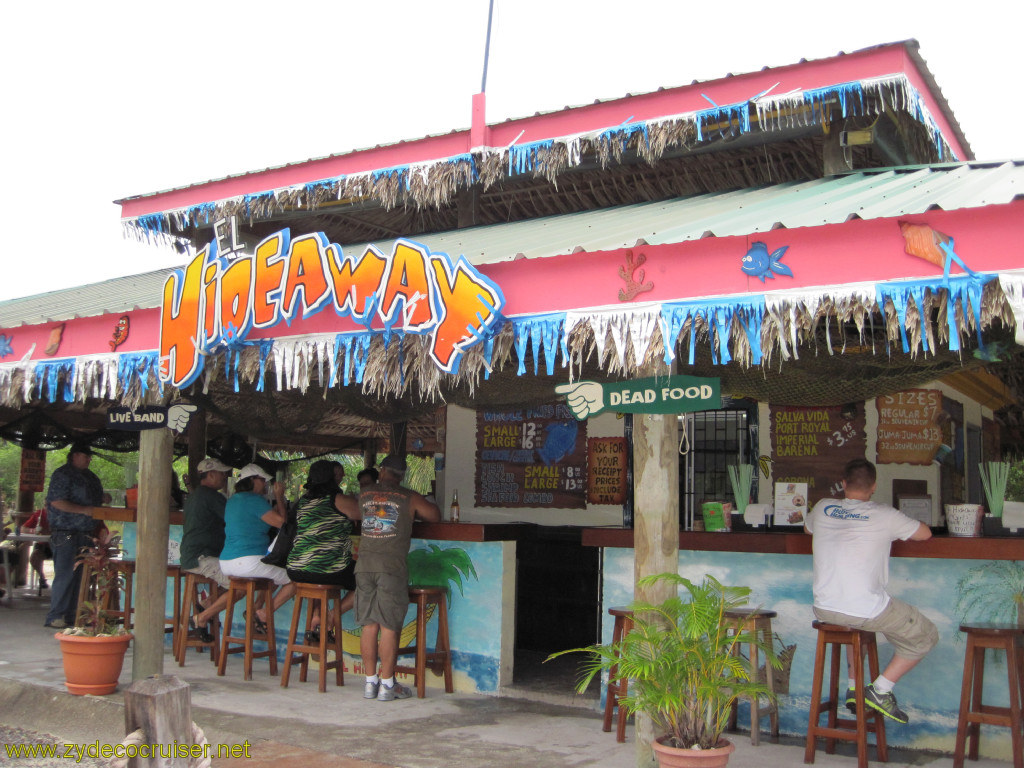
[555,376,722,420]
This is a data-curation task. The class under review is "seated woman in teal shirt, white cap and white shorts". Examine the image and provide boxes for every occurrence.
[220,464,295,629]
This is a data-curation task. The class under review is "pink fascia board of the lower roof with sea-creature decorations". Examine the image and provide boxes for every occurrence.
[6,201,1024,362]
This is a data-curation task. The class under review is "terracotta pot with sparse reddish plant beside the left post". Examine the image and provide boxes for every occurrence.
[55,544,132,696]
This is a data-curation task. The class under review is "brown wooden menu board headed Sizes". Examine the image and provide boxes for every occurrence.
[876,389,942,465]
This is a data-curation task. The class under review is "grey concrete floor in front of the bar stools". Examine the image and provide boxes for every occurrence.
[0,599,1008,768]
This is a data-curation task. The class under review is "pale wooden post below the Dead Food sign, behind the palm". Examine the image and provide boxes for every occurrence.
[633,414,679,768]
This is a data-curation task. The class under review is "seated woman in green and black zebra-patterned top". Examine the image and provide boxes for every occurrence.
[287,460,361,627]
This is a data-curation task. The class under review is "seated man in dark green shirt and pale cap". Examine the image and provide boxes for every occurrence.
[180,459,231,640]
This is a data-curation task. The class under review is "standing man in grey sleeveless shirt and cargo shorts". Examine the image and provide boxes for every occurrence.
[355,456,441,701]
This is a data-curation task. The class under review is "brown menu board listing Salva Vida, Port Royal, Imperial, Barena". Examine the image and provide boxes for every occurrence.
[770,402,867,509]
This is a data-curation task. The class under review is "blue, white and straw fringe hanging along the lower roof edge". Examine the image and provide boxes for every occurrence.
[0,274,1024,408]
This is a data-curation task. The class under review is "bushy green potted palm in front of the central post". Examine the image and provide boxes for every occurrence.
[549,573,779,767]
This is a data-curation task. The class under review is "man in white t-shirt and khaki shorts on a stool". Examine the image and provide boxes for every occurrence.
[804,459,939,723]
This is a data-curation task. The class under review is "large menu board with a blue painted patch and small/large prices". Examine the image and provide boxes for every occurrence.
[475,402,587,509]
